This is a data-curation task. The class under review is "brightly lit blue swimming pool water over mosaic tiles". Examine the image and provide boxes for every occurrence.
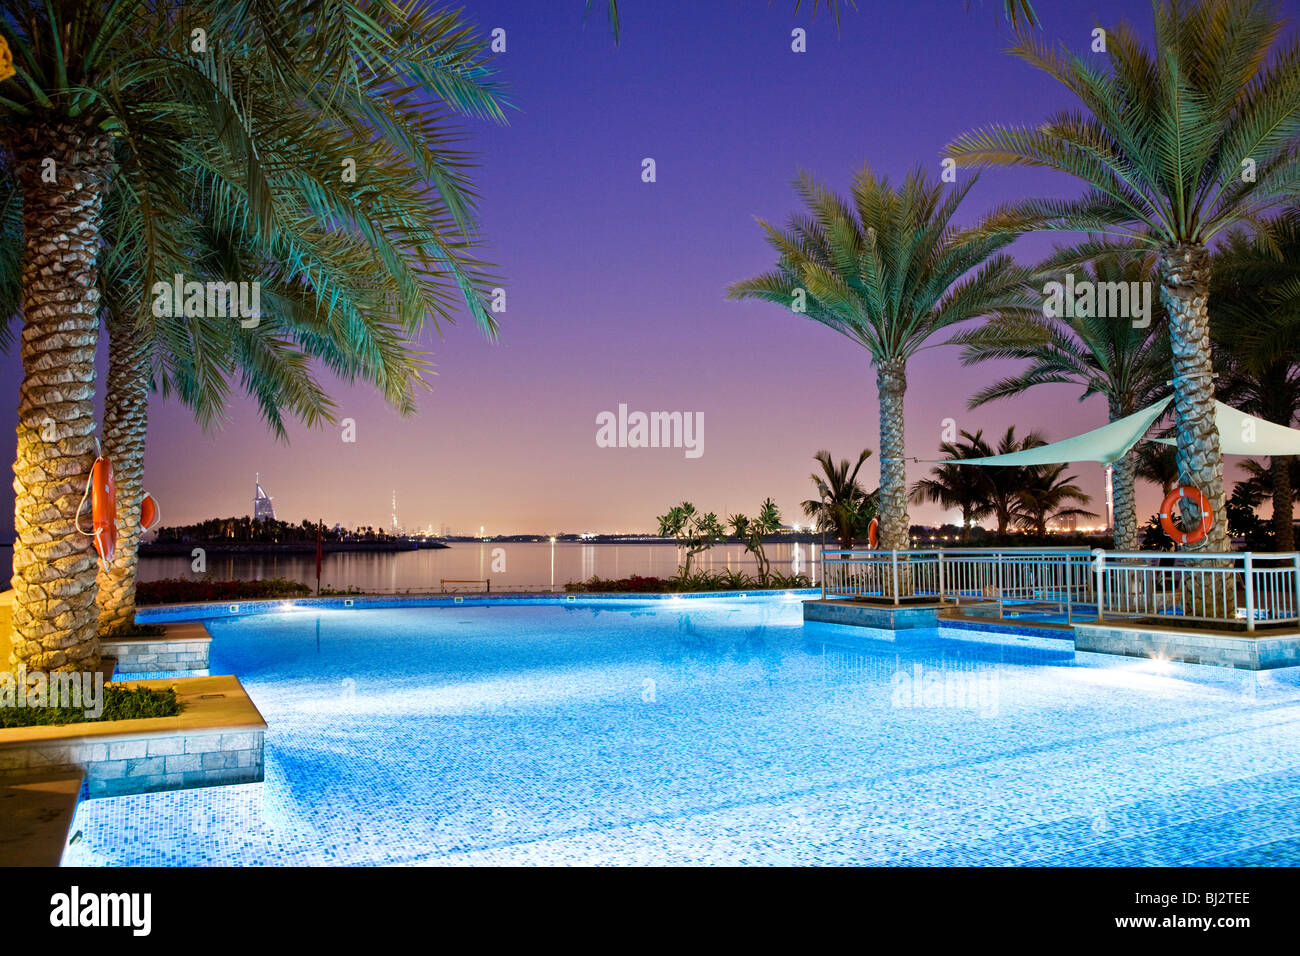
[65,598,1300,865]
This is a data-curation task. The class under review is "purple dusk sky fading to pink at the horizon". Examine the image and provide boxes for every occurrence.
[0,0,1295,538]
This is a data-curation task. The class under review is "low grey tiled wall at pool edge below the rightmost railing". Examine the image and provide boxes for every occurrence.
[1074,622,1300,670]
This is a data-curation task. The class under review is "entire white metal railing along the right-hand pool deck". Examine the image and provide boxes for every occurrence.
[822,548,1300,631]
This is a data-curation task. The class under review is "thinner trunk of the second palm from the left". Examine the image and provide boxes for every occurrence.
[99,316,150,631]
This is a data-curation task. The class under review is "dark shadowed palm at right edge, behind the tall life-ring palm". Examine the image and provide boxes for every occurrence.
[1210,211,1300,551]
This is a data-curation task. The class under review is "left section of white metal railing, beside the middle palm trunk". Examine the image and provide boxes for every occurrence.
[822,548,1095,620]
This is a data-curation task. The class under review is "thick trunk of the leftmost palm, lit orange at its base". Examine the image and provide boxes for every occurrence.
[10,123,112,671]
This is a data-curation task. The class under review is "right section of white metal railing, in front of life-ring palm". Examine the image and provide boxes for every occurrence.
[1092,550,1300,631]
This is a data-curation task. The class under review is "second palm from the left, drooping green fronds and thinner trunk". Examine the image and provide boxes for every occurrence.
[85,21,495,631]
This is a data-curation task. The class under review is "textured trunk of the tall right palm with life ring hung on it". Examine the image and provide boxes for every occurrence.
[1160,245,1230,551]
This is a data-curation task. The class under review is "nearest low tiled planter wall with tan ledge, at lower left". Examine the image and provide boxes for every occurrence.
[0,676,267,797]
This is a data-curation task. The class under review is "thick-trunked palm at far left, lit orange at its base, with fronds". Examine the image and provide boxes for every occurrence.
[0,0,498,671]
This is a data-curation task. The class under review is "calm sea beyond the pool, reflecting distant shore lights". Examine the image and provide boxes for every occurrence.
[0,541,820,591]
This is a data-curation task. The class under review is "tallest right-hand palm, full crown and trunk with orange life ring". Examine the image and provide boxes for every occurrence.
[948,0,1300,551]
